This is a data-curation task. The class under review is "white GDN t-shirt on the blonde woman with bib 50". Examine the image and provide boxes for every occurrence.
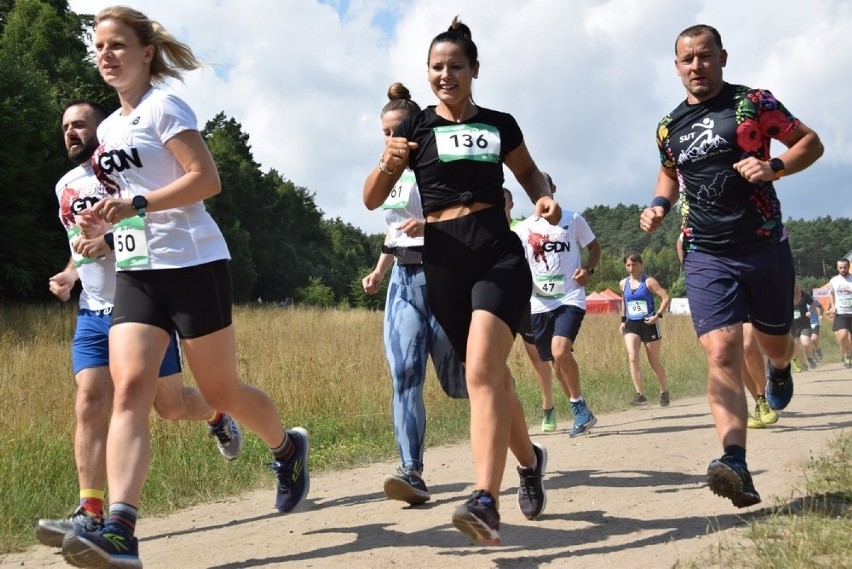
[92,88,230,270]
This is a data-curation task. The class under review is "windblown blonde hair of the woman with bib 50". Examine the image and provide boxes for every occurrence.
[95,6,204,83]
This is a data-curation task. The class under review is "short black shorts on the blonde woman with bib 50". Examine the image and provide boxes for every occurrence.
[112,260,233,338]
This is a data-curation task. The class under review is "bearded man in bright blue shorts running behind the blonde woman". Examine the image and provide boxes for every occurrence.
[36,100,243,547]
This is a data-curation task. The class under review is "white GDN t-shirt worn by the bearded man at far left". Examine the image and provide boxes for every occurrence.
[56,164,115,310]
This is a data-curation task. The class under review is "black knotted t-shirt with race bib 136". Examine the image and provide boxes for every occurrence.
[393,106,524,214]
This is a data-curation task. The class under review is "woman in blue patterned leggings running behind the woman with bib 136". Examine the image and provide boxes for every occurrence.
[362,83,467,505]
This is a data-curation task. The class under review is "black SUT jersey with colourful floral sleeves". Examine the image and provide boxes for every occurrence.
[657,83,799,253]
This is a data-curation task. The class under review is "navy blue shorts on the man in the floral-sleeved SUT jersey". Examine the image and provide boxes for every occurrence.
[683,241,795,336]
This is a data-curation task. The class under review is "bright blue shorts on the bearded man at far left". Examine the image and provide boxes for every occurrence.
[71,308,181,377]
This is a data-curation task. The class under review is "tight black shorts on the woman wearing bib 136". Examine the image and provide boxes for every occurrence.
[423,207,532,361]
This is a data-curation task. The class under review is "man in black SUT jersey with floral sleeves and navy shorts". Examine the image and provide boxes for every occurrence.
[640,25,823,507]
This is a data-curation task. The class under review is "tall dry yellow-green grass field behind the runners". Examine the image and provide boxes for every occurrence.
[0,305,848,553]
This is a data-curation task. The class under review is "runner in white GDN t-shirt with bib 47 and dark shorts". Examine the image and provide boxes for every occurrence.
[514,174,601,437]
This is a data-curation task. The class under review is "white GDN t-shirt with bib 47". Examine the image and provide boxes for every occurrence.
[513,211,595,314]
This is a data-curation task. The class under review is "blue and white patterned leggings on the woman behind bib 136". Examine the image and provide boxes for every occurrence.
[384,265,467,472]
